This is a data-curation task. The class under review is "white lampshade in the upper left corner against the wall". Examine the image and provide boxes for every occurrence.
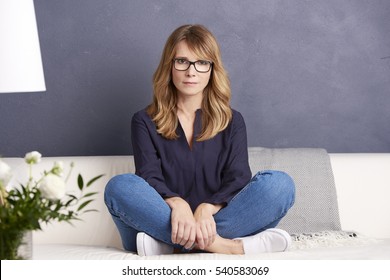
[0,0,46,93]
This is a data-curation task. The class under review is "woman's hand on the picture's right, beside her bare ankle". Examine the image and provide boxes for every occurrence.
[194,203,222,250]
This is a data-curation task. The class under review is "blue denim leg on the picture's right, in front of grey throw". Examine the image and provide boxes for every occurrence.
[214,170,295,239]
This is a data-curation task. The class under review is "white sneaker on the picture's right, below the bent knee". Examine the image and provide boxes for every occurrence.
[237,228,291,255]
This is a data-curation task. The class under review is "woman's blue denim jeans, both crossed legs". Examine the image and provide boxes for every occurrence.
[104,170,295,252]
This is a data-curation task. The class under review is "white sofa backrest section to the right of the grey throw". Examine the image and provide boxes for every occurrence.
[330,153,390,238]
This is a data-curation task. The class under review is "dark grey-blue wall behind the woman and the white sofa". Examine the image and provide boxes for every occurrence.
[0,0,390,156]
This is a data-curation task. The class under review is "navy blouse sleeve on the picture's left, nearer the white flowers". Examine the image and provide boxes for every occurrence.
[131,111,178,197]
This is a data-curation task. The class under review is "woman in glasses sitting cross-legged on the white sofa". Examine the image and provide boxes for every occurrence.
[105,25,295,256]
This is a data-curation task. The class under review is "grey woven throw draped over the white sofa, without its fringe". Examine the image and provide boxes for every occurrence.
[249,147,341,234]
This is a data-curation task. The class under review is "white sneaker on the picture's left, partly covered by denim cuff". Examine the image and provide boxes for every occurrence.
[137,232,173,256]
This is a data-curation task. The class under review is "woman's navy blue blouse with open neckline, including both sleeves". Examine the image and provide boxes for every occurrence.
[131,107,251,210]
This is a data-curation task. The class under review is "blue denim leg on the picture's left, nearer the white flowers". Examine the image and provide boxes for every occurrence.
[104,174,173,252]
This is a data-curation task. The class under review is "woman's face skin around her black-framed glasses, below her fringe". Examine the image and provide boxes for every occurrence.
[172,40,211,99]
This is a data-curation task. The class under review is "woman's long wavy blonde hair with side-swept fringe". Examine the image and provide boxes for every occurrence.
[147,25,232,141]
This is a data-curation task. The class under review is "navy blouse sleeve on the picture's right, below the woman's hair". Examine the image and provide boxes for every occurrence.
[206,111,252,204]
